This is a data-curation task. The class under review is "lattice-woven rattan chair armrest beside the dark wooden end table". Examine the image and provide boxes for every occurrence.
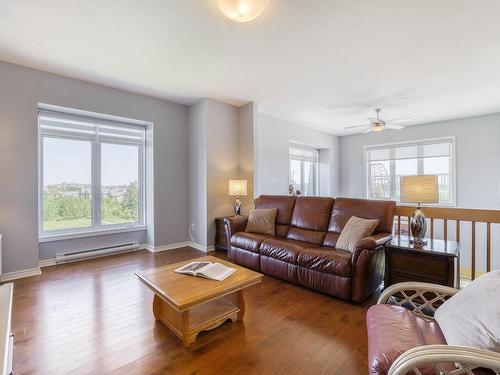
[377,281,458,319]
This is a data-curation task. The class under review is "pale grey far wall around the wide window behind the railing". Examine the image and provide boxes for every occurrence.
[340,113,500,272]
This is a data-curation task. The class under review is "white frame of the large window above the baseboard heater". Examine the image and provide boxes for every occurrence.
[37,104,147,243]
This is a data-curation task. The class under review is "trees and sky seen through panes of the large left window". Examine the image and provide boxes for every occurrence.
[41,125,142,232]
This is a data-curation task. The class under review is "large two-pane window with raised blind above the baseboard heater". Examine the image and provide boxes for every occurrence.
[38,109,145,238]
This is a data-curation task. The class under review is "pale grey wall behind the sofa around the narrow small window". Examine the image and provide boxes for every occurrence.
[254,114,339,196]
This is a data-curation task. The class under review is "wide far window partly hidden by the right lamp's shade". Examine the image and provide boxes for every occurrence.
[366,138,455,205]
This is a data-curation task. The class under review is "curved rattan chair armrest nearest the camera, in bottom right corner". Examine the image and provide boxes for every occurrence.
[387,345,500,375]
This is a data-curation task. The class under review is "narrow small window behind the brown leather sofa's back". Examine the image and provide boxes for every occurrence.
[289,144,319,195]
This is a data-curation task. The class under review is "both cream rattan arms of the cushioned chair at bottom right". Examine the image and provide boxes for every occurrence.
[370,282,500,375]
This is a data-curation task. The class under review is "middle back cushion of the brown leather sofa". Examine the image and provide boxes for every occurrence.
[286,197,333,245]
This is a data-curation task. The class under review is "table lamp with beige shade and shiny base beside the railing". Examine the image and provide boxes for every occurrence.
[401,175,439,245]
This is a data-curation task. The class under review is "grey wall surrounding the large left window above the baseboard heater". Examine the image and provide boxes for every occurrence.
[0,62,189,272]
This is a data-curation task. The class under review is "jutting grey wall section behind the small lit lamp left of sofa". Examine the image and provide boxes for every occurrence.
[189,99,255,247]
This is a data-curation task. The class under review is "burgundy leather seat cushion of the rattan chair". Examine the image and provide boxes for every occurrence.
[366,305,446,375]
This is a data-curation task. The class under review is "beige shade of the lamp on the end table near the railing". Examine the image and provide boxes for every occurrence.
[401,175,439,203]
